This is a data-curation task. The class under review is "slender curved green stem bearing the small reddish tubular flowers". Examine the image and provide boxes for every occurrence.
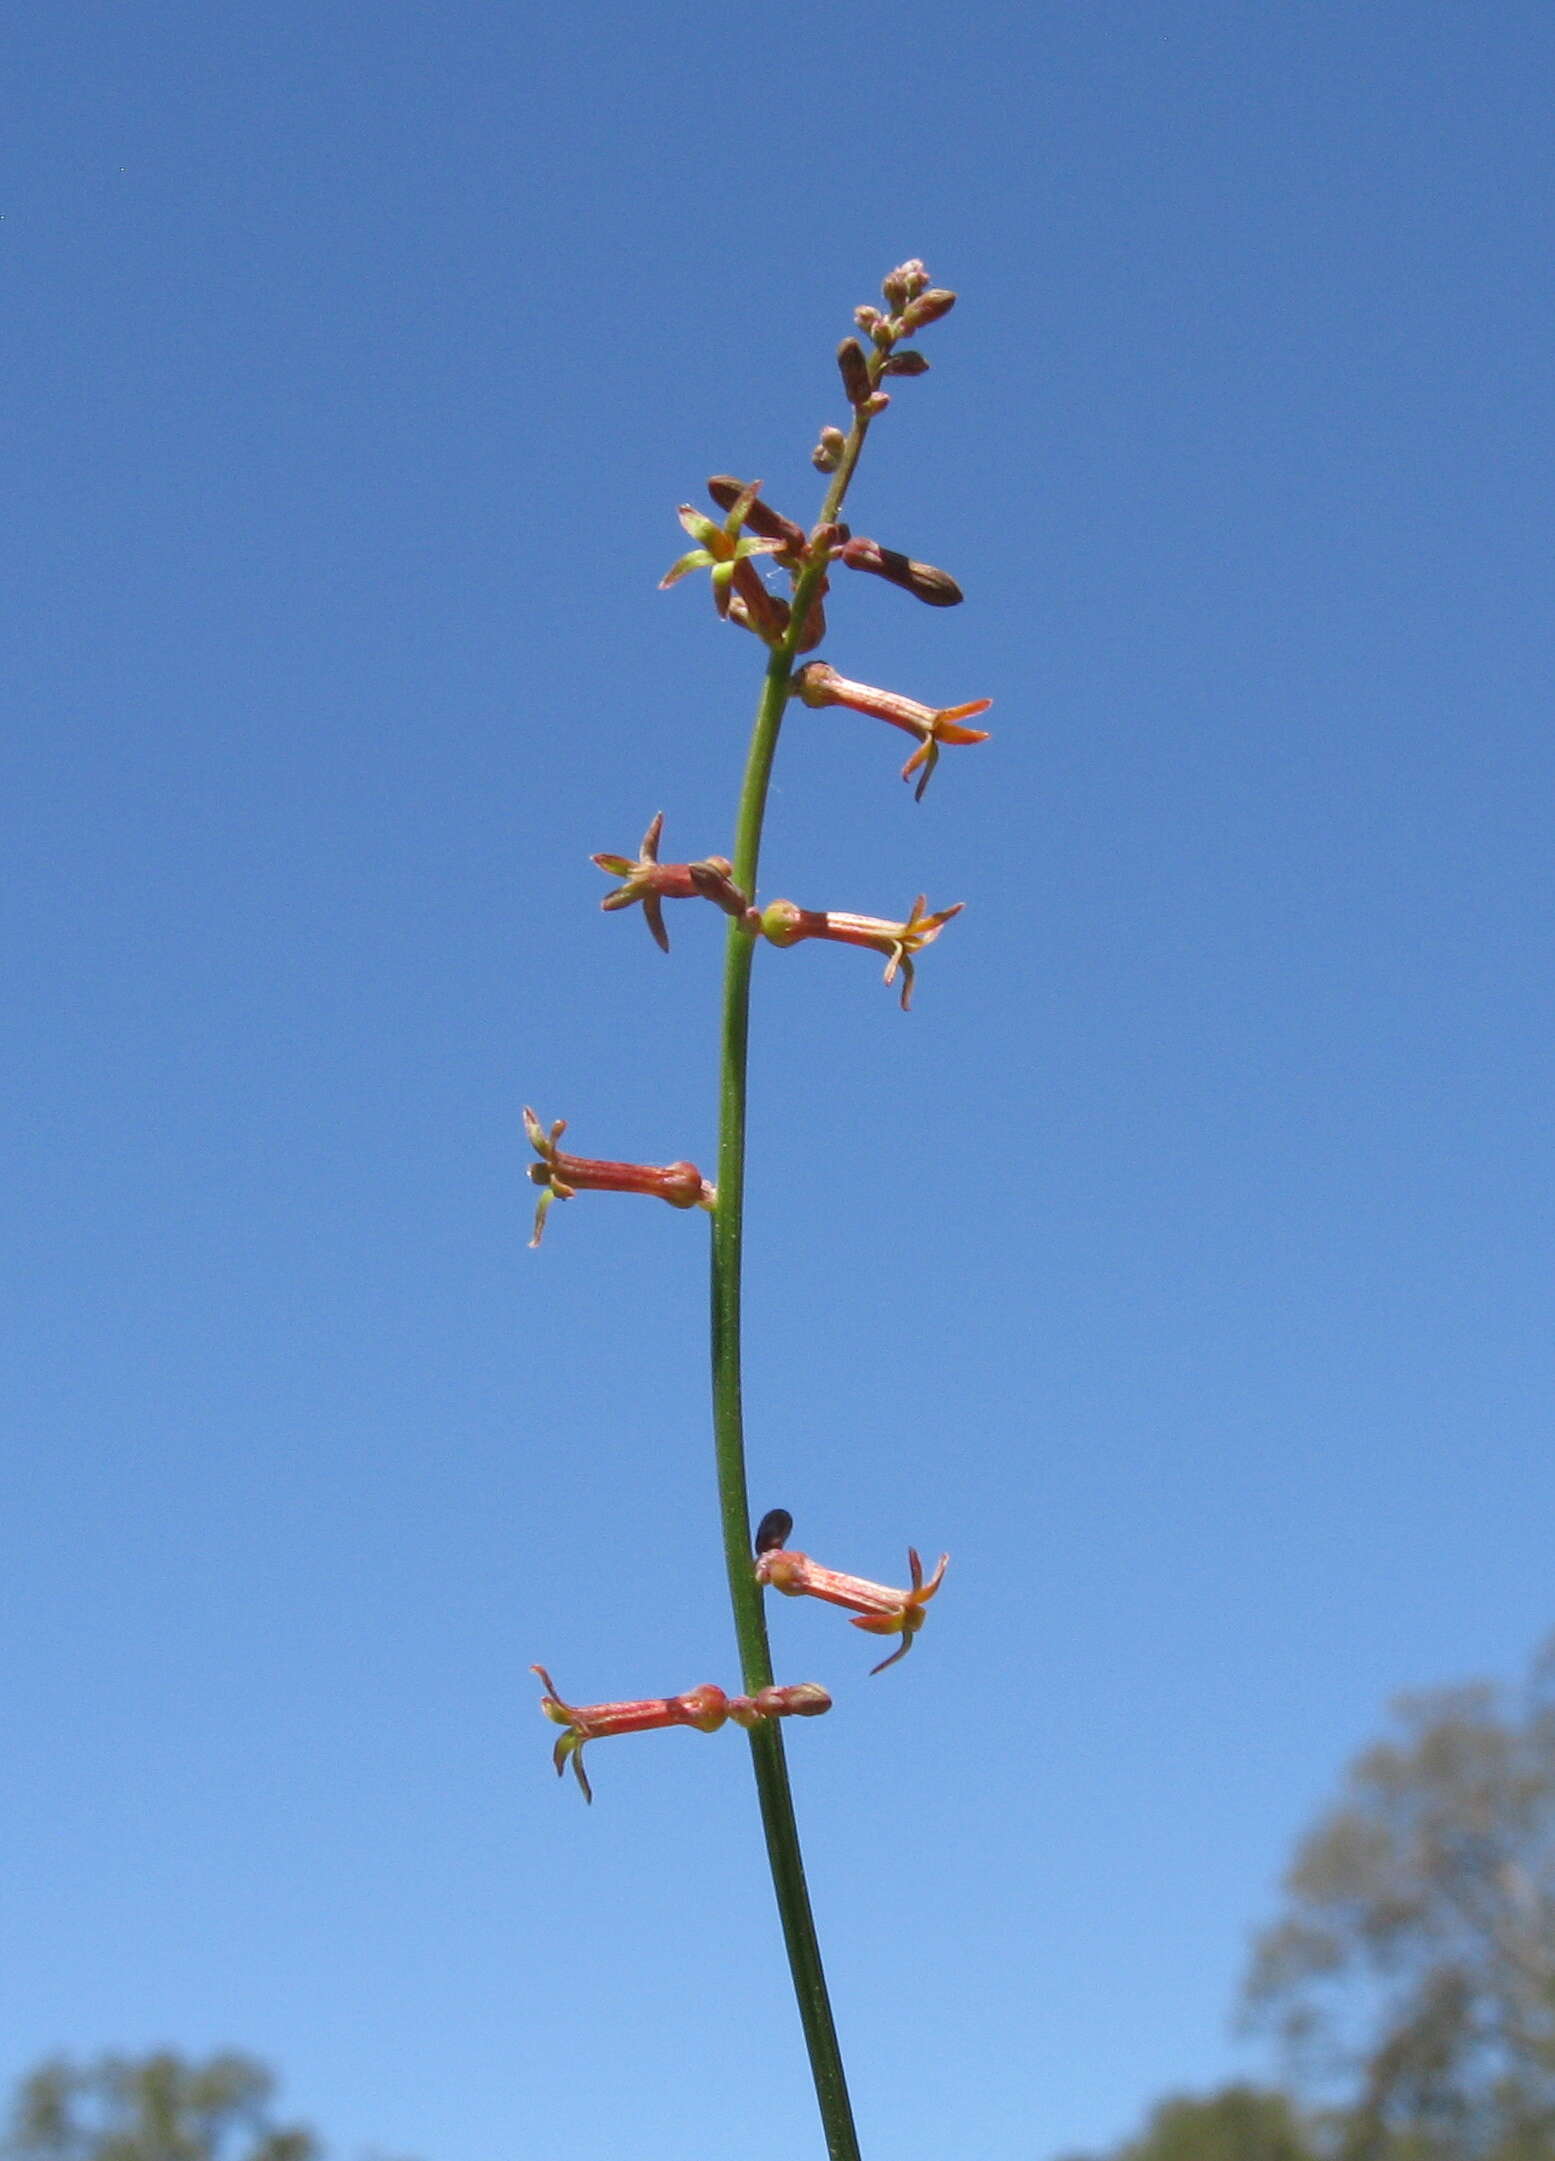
[713,413,868,2161]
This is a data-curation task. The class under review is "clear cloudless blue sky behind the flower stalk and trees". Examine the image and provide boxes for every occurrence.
[0,12,1555,2161]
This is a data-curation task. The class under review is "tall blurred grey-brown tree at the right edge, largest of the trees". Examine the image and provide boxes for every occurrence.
[1246,1642,1555,2161]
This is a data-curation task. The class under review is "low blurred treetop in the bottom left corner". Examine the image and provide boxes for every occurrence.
[0,2049,317,2161]
